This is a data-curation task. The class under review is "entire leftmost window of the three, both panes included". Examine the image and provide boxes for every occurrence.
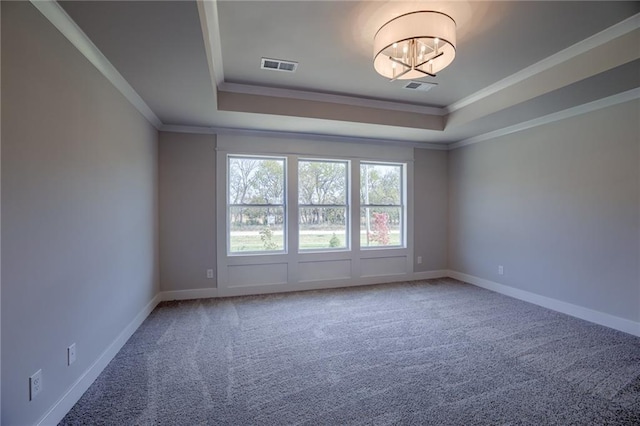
[227,155,287,254]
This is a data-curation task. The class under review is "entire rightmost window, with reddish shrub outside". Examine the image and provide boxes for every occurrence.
[360,162,405,248]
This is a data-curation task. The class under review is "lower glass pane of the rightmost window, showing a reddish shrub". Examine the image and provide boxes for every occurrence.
[360,207,404,247]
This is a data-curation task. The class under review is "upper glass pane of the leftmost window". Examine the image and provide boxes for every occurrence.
[229,157,285,204]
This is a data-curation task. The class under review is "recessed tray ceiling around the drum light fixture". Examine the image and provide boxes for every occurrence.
[56,0,640,144]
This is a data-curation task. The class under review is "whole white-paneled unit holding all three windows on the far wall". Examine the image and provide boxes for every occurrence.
[216,136,414,290]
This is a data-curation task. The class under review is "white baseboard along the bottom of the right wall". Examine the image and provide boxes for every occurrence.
[448,271,640,337]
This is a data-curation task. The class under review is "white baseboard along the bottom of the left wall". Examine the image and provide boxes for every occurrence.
[37,294,161,425]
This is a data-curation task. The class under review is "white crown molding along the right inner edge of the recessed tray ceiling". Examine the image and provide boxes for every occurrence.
[444,13,640,114]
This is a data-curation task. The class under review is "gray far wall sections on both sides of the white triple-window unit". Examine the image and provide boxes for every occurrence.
[158,136,447,291]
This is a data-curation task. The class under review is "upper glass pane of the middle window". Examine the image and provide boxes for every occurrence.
[298,160,347,204]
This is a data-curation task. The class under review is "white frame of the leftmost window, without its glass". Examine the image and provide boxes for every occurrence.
[225,153,289,257]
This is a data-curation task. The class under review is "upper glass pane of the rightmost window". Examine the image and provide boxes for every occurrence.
[360,163,402,206]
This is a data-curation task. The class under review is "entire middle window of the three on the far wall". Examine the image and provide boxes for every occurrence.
[298,160,349,251]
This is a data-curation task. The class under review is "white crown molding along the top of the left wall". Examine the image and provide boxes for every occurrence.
[31,0,162,129]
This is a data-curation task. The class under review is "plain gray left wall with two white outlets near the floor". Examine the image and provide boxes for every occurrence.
[1,2,158,425]
